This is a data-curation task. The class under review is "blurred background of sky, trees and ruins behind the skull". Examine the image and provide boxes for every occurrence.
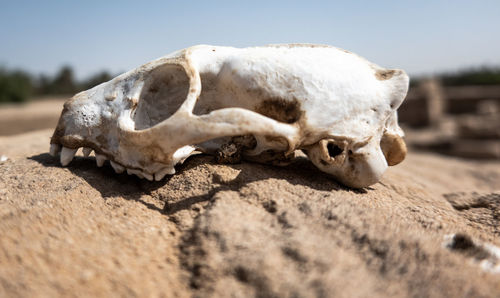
[0,0,500,159]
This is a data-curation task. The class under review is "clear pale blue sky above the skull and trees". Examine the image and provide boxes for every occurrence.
[0,0,500,78]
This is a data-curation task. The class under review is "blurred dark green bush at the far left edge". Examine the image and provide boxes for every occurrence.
[0,68,32,103]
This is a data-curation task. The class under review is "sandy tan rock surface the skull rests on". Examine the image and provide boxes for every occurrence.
[0,130,500,297]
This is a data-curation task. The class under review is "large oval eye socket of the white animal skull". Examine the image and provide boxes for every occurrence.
[132,64,189,130]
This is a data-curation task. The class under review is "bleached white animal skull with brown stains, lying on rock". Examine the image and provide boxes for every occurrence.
[51,44,408,188]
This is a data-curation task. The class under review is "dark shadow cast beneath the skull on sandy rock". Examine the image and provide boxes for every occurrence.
[29,153,371,215]
